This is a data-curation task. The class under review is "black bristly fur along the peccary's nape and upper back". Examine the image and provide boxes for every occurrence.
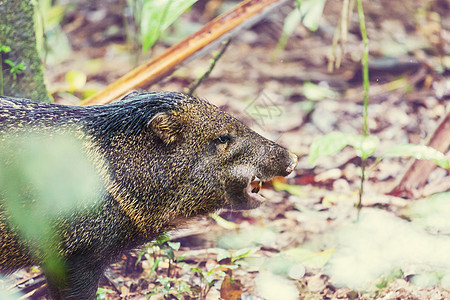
[0,92,188,138]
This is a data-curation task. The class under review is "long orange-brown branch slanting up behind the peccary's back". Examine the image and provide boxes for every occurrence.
[80,0,284,106]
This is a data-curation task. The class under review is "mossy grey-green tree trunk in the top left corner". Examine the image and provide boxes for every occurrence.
[0,0,50,102]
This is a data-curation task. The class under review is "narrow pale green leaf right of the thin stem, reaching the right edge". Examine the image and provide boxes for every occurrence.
[383,144,449,169]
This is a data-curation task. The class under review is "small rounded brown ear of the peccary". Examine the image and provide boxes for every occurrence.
[148,112,182,145]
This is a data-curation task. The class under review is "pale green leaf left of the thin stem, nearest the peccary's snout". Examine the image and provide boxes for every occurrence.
[309,132,380,165]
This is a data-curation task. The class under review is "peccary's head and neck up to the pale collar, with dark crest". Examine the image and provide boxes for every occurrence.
[89,93,297,232]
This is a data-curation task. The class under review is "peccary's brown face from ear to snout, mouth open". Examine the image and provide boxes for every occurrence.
[149,93,297,209]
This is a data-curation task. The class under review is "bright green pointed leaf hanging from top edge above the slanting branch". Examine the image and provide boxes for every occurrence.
[141,0,198,51]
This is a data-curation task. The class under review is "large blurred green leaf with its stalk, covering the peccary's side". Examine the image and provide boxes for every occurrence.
[0,132,100,280]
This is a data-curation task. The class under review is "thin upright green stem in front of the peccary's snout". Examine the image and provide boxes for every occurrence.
[356,0,370,218]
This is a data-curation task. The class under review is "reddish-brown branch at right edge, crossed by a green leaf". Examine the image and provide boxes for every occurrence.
[389,112,450,197]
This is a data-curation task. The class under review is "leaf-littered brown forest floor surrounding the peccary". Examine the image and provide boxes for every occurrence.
[3,0,450,299]
